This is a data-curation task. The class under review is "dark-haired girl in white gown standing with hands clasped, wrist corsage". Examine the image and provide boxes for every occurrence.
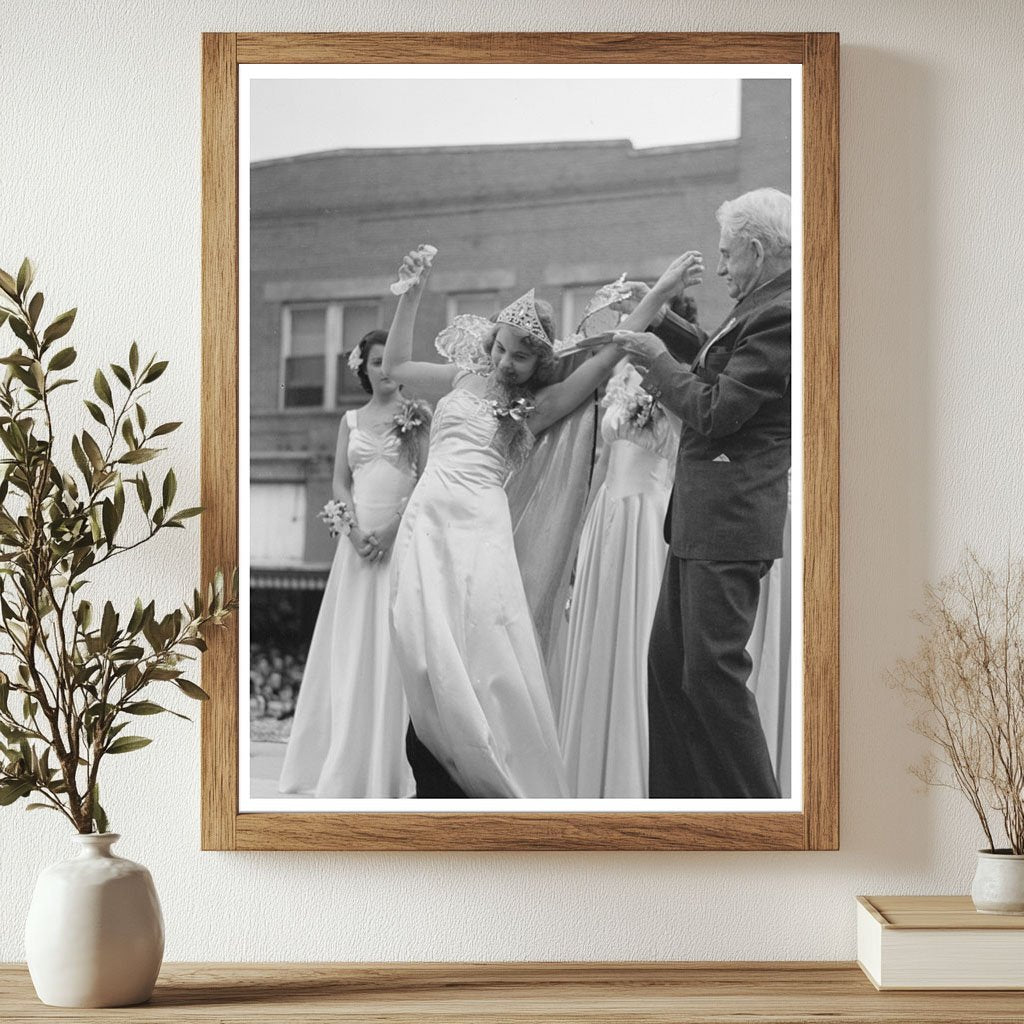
[280,331,429,798]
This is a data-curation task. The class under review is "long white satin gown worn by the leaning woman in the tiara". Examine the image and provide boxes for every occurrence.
[391,374,568,799]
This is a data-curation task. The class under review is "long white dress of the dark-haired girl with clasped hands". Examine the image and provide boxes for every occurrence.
[279,411,416,799]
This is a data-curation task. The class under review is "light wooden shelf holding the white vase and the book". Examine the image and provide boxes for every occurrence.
[0,963,1024,1024]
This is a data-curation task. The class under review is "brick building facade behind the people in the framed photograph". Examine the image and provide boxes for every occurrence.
[249,80,791,593]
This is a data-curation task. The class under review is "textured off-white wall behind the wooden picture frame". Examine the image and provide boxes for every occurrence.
[0,0,1024,961]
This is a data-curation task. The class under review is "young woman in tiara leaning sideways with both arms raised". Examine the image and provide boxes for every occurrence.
[384,243,693,799]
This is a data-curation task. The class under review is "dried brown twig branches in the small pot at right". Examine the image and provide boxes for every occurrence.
[895,553,1024,854]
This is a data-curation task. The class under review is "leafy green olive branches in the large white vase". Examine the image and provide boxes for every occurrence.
[0,259,238,834]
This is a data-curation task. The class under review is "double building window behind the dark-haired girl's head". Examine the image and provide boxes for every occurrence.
[281,299,381,409]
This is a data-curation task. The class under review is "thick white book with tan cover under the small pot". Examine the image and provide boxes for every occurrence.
[857,896,1024,987]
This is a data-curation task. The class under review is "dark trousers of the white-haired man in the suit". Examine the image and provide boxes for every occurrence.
[647,554,780,799]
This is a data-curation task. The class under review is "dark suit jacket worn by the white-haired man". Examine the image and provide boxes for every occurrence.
[644,270,792,561]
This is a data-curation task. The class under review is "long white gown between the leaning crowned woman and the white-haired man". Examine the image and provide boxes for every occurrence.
[558,366,678,799]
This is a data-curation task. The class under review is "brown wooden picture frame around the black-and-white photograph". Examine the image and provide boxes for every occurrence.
[202,33,839,851]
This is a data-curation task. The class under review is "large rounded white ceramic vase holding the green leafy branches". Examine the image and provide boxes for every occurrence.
[25,833,164,1007]
